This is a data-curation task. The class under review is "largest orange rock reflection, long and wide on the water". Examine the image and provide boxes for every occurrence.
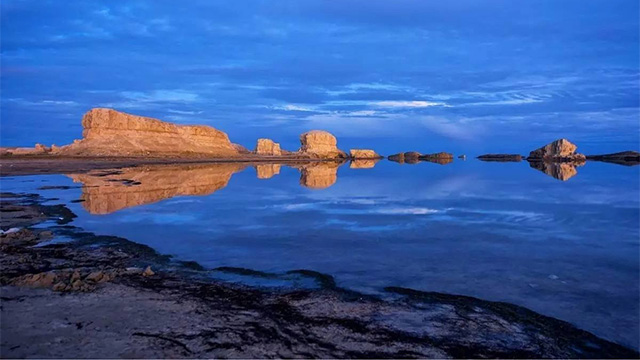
[69,163,246,214]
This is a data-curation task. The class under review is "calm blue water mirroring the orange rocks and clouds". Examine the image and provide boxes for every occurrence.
[0,159,640,349]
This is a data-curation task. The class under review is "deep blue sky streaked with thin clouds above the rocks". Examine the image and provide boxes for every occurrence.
[0,0,640,155]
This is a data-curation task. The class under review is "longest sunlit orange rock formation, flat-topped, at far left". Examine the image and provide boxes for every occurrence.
[55,108,238,157]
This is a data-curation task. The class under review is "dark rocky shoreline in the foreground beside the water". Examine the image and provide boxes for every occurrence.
[0,193,639,358]
